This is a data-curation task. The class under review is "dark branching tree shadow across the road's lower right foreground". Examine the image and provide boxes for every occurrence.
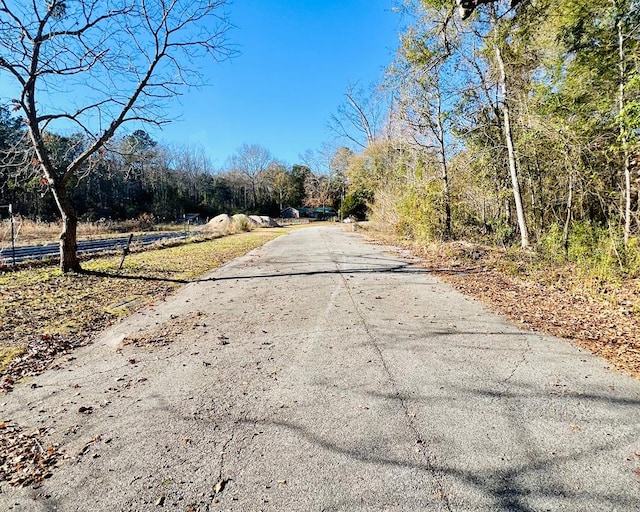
[243,384,640,512]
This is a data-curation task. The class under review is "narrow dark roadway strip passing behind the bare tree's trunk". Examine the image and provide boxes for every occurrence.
[0,231,194,265]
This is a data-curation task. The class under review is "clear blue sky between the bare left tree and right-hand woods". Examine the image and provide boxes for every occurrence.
[150,0,400,168]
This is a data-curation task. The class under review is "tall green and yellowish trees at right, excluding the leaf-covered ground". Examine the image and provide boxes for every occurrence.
[341,0,640,274]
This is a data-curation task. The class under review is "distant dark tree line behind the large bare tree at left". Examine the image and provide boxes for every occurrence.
[0,116,338,222]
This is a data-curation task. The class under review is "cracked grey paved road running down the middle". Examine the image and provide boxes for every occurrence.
[0,227,640,511]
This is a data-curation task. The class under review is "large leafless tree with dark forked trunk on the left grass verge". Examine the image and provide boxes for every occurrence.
[0,0,230,272]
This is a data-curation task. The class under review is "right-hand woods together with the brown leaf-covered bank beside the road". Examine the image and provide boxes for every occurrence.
[336,0,640,376]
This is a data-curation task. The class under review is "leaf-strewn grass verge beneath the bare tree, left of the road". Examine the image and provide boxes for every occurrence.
[0,228,288,390]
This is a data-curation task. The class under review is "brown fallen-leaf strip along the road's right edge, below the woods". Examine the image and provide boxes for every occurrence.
[404,242,640,379]
